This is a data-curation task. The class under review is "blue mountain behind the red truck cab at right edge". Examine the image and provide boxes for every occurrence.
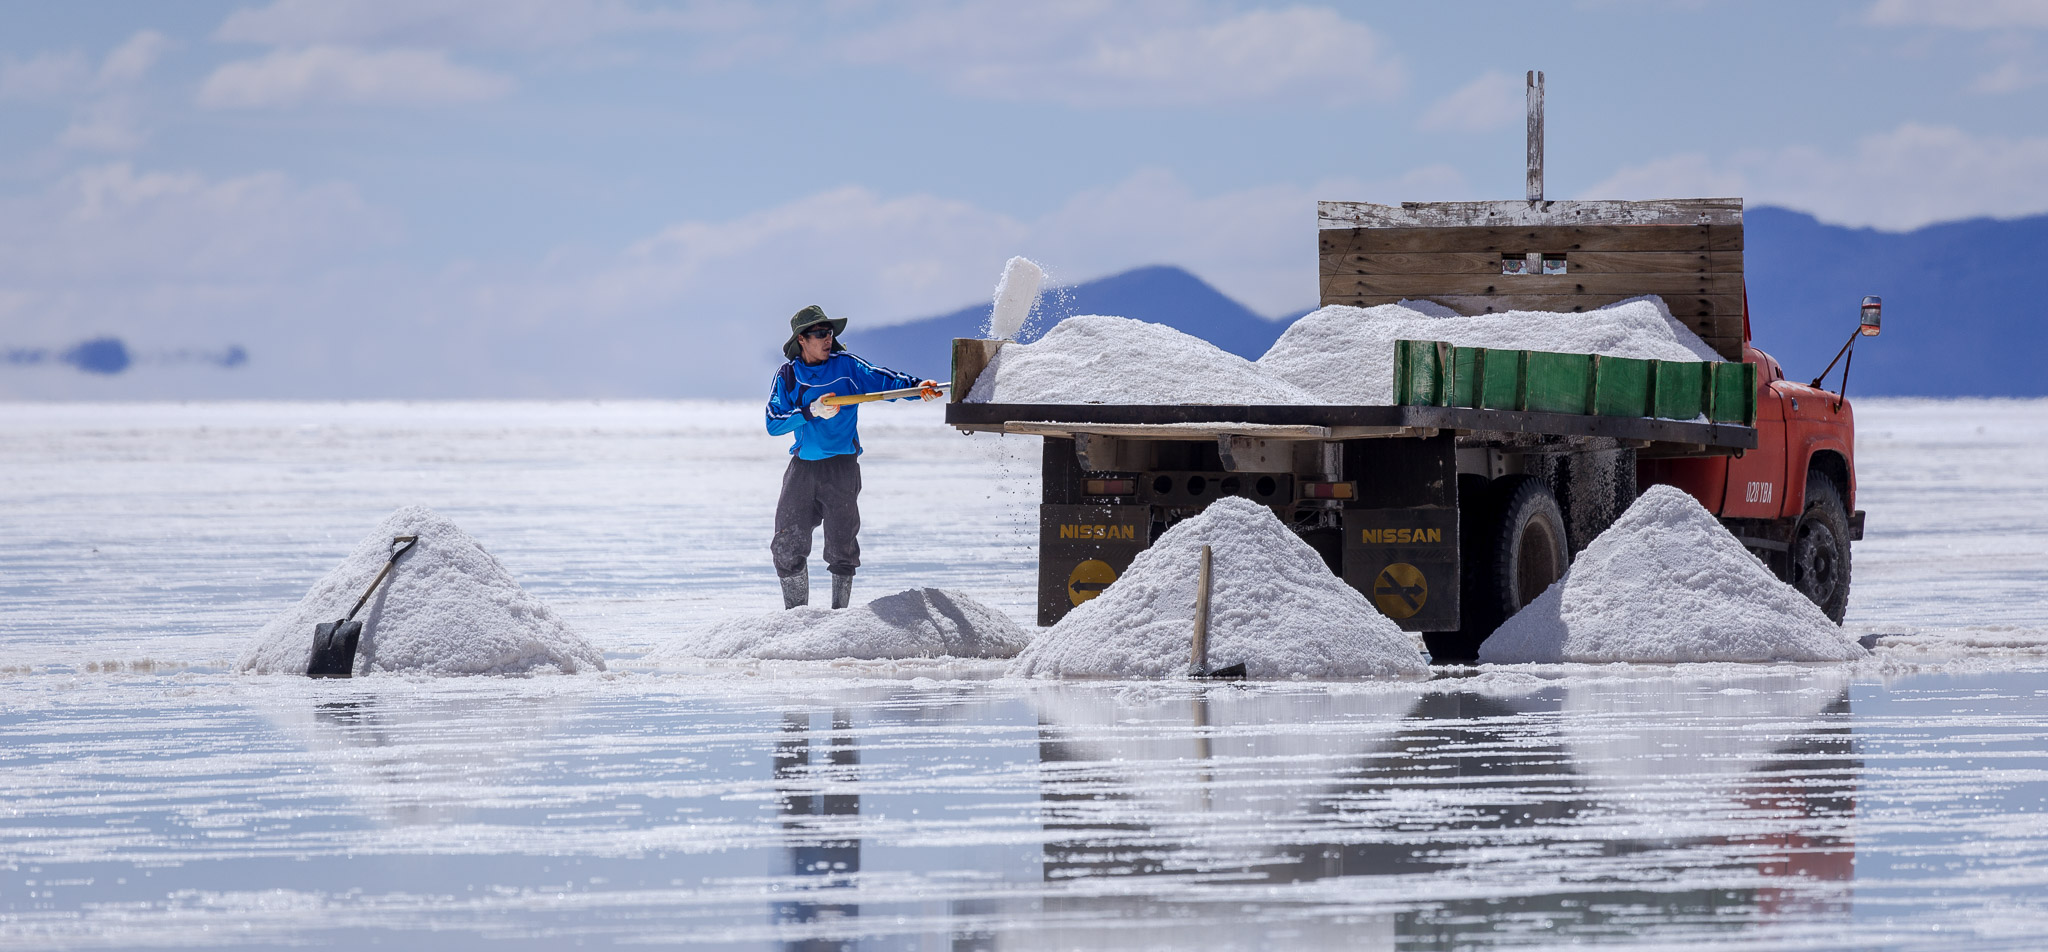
[1743,207,2048,397]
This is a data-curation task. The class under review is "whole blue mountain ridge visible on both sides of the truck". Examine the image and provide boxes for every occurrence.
[846,207,2048,397]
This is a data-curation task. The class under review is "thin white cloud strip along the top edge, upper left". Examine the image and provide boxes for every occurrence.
[215,0,724,49]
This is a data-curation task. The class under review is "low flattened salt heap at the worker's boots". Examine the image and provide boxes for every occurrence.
[649,588,1030,661]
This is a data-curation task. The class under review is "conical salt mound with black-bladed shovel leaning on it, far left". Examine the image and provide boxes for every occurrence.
[236,506,604,676]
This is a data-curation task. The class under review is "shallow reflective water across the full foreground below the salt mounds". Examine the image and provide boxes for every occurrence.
[0,669,2048,950]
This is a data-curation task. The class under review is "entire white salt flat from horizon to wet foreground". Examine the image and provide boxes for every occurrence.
[0,399,2048,952]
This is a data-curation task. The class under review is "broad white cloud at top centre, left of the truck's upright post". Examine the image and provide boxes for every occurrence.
[836,0,1405,106]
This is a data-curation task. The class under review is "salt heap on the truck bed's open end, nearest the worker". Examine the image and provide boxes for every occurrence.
[967,315,1318,403]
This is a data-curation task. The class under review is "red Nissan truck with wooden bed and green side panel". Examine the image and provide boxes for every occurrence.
[946,196,1880,661]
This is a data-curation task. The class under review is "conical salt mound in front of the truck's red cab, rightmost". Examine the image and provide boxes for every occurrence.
[1479,485,1868,663]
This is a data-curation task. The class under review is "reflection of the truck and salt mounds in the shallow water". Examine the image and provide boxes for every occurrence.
[1032,674,1862,948]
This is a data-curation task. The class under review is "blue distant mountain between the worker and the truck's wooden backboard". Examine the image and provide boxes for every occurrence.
[846,266,1286,379]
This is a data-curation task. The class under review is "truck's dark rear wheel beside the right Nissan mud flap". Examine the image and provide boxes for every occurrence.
[1423,475,1571,663]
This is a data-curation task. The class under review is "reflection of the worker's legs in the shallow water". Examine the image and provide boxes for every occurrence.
[774,710,860,952]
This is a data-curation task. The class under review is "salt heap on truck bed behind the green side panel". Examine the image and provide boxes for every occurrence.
[1260,297,1720,405]
